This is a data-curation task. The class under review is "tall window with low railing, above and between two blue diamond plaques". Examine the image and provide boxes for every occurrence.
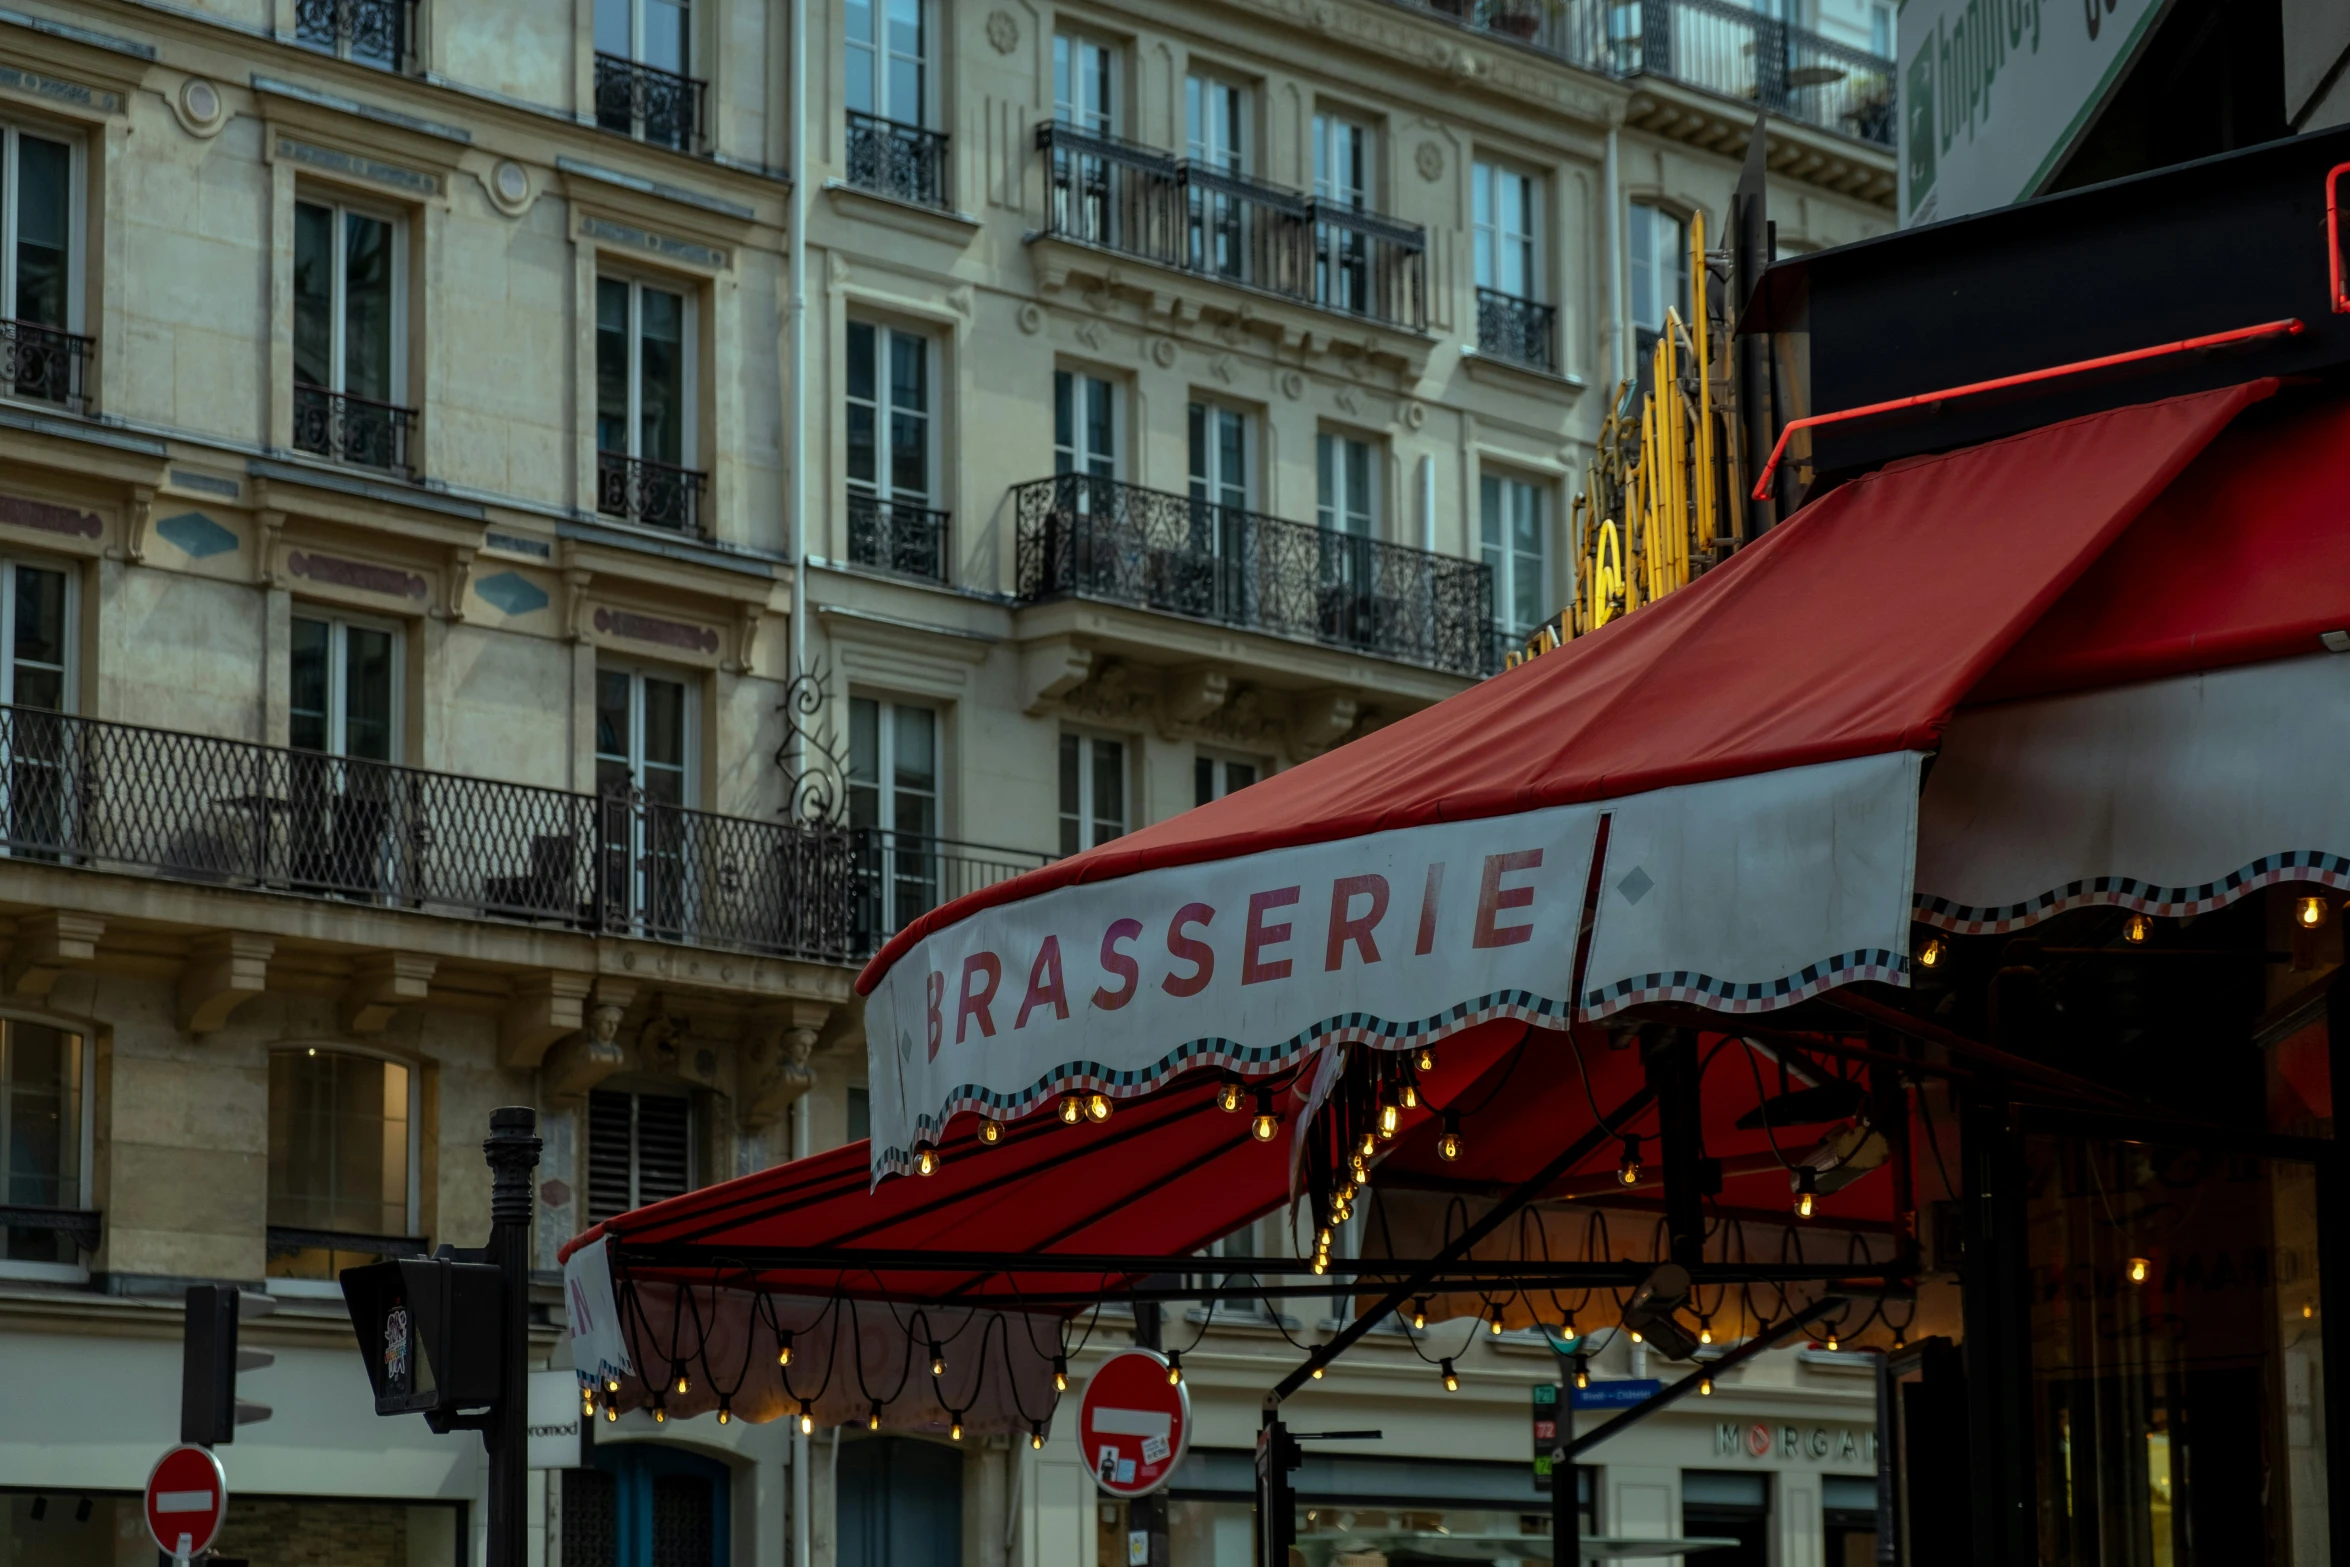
[294,202,411,468]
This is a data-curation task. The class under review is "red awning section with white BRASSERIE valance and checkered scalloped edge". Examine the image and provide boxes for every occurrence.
[858,383,2315,1179]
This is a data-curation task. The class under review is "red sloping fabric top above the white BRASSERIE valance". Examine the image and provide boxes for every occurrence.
[858,381,2275,994]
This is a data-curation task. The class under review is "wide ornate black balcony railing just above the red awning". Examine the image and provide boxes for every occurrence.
[1013,475,1497,677]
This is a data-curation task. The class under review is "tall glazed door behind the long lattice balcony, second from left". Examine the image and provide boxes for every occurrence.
[290,616,400,897]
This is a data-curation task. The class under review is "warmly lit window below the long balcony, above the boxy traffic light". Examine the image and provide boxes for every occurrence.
[268,1045,418,1280]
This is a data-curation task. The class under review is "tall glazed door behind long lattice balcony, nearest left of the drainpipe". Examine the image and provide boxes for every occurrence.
[595,667,698,935]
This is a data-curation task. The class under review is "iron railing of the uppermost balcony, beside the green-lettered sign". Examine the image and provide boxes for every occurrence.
[1405,0,1896,148]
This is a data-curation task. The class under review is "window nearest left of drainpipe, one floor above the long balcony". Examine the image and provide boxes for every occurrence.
[595,277,700,531]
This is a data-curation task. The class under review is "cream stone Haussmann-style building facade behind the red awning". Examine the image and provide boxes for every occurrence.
[0,0,1894,1567]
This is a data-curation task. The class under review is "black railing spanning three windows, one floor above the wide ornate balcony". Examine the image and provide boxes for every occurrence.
[1036,122,1429,331]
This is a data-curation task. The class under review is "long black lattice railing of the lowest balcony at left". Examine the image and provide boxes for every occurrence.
[0,707,860,961]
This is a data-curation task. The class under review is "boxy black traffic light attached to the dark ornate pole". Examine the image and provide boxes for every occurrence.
[343,1247,505,1431]
